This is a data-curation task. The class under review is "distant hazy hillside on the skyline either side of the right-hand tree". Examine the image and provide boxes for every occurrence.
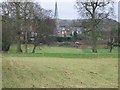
[59,19,120,30]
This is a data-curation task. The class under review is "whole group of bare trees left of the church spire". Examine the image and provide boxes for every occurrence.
[0,2,55,53]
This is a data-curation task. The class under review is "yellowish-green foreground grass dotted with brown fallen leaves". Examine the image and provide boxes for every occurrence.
[2,56,118,88]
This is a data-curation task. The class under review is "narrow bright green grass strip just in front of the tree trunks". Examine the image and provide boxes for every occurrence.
[4,53,118,58]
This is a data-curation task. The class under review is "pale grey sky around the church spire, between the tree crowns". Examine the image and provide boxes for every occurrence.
[40,2,78,19]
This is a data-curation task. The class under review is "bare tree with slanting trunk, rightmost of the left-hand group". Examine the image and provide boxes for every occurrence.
[32,4,55,53]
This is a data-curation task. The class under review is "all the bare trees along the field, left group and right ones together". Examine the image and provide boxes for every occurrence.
[0,0,118,53]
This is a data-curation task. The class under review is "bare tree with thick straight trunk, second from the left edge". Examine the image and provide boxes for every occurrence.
[1,2,22,52]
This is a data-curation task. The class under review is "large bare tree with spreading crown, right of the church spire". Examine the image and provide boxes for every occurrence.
[75,0,114,53]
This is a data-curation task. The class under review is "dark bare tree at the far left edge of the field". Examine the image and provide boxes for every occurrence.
[0,2,14,51]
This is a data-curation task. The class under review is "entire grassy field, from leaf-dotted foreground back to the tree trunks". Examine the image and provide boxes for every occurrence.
[2,46,118,88]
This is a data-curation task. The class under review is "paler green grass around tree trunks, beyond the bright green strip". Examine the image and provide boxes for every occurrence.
[10,45,118,54]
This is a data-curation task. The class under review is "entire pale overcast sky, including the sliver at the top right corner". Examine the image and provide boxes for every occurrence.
[36,0,120,20]
